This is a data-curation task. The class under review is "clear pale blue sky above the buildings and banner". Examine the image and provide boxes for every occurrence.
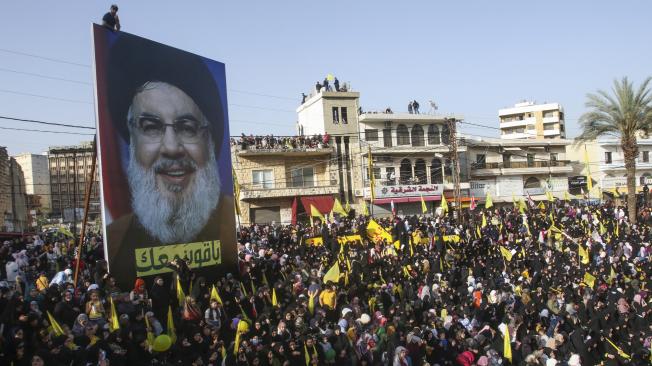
[0,0,652,155]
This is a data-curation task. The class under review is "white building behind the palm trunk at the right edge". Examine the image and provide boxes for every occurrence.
[569,138,652,199]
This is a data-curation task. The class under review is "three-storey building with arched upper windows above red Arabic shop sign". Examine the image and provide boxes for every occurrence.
[356,113,469,215]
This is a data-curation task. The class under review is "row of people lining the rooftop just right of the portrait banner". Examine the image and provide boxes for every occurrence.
[231,133,330,150]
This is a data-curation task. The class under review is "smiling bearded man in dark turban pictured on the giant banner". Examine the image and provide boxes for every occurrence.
[99,28,235,286]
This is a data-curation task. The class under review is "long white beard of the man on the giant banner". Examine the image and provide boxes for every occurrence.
[127,141,221,244]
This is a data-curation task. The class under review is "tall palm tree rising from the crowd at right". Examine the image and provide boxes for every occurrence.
[577,77,652,223]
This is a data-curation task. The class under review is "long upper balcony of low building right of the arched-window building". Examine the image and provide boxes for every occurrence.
[471,160,573,177]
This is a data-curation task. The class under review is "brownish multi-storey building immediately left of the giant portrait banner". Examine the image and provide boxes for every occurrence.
[48,142,100,224]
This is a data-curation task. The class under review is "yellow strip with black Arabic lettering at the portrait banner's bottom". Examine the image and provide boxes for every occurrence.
[135,240,222,276]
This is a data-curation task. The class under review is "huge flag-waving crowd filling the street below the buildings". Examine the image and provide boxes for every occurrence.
[0,202,652,366]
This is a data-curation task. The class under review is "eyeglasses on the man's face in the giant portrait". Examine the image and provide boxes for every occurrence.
[135,116,208,144]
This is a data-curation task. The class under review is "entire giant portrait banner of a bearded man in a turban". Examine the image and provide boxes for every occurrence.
[93,25,237,288]
